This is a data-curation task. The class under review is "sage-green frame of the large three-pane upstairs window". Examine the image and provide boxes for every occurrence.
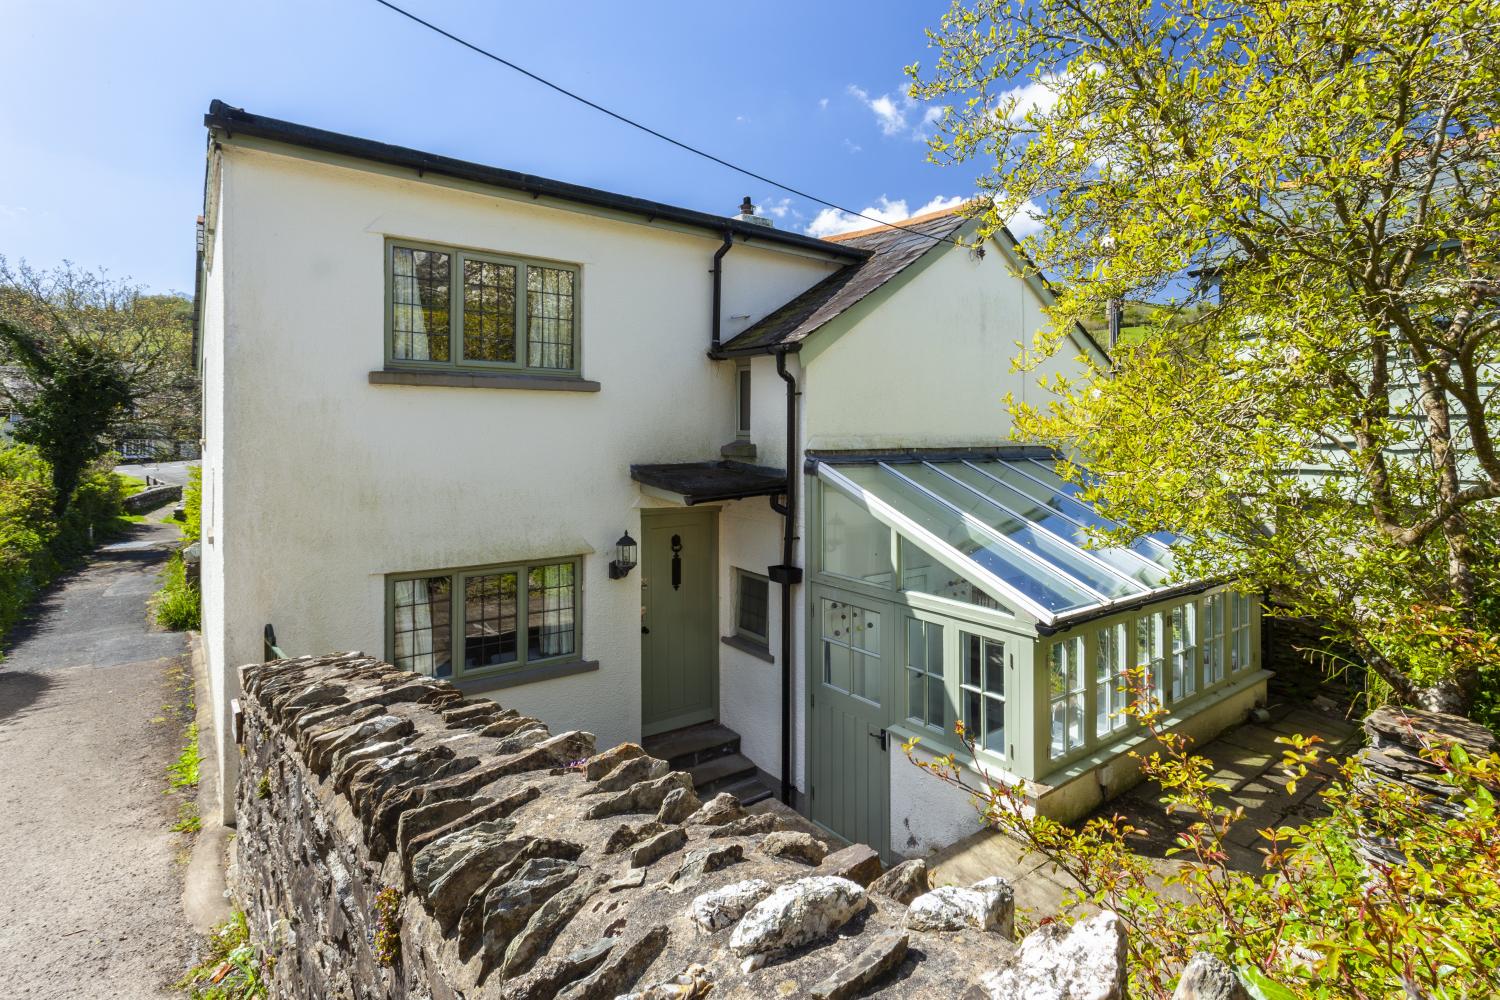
[383,235,584,378]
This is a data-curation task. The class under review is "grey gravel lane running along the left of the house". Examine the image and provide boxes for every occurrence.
[0,513,192,1000]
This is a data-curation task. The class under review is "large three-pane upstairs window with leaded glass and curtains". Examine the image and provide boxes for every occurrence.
[386,241,578,375]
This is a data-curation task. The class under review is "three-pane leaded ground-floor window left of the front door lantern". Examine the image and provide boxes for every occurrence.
[387,559,579,678]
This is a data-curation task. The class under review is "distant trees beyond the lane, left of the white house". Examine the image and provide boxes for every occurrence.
[0,258,197,514]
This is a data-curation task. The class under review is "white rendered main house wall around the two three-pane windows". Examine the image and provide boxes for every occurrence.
[204,142,833,815]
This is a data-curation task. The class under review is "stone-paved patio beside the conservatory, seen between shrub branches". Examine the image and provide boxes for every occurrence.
[927,706,1359,919]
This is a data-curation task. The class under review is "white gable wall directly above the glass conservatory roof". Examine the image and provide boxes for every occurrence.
[801,243,1098,450]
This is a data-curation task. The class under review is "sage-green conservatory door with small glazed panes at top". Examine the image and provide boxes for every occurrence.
[809,591,897,856]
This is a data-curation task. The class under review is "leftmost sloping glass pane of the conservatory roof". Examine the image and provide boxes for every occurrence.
[824,465,1100,613]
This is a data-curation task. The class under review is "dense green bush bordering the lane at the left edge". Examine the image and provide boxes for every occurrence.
[0,445,125,634]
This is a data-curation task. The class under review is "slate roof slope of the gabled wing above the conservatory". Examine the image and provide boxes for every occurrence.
[722,205,968,354]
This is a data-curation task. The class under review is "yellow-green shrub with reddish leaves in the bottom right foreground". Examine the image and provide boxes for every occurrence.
[905,683,1500,1000]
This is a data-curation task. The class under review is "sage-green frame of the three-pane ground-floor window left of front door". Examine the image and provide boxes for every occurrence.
[384,555,584,682]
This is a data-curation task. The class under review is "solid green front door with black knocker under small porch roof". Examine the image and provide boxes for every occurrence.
[641,508,719,736]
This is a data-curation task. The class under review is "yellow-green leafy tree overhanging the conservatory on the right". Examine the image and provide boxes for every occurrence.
[909,0,1500,711]
